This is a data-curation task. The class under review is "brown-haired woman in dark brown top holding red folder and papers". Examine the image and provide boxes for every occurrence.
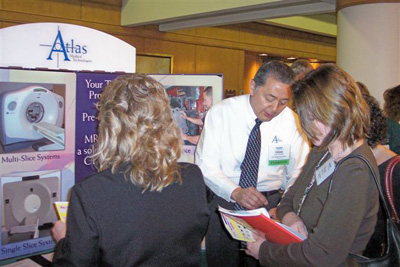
[246,64,379,266]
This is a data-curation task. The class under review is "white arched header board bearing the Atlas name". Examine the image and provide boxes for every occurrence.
[0,23,136,73]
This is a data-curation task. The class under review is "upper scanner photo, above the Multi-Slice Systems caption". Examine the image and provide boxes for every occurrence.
[0,85,64,152]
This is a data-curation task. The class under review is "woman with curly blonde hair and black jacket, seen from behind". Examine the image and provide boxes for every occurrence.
[52,74,209,266]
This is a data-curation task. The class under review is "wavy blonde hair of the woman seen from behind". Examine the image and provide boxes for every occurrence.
[92,74,182,192]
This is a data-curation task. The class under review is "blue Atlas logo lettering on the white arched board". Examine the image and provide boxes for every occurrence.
[40,29,92,67]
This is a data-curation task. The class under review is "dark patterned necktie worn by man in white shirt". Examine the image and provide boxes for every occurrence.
[235,118,262,210]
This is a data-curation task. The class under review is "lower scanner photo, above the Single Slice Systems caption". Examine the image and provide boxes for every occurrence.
[1,170,61,245]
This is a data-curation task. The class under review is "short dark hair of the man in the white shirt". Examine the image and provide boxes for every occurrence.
[254,61,294,90]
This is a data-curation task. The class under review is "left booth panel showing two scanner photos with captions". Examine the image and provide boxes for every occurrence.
[0,69,76,259]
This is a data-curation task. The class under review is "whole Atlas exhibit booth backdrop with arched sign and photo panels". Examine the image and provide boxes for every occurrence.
[0,23,223,260]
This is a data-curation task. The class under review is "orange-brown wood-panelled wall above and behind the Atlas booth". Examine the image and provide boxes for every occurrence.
[0,0,336,94]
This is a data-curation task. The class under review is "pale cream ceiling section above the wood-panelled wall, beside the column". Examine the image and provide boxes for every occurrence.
[121,0,337,37]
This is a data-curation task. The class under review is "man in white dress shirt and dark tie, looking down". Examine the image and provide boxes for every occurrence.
[195,61,309,267]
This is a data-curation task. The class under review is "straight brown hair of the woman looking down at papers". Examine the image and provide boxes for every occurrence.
[292,64,370,149]
